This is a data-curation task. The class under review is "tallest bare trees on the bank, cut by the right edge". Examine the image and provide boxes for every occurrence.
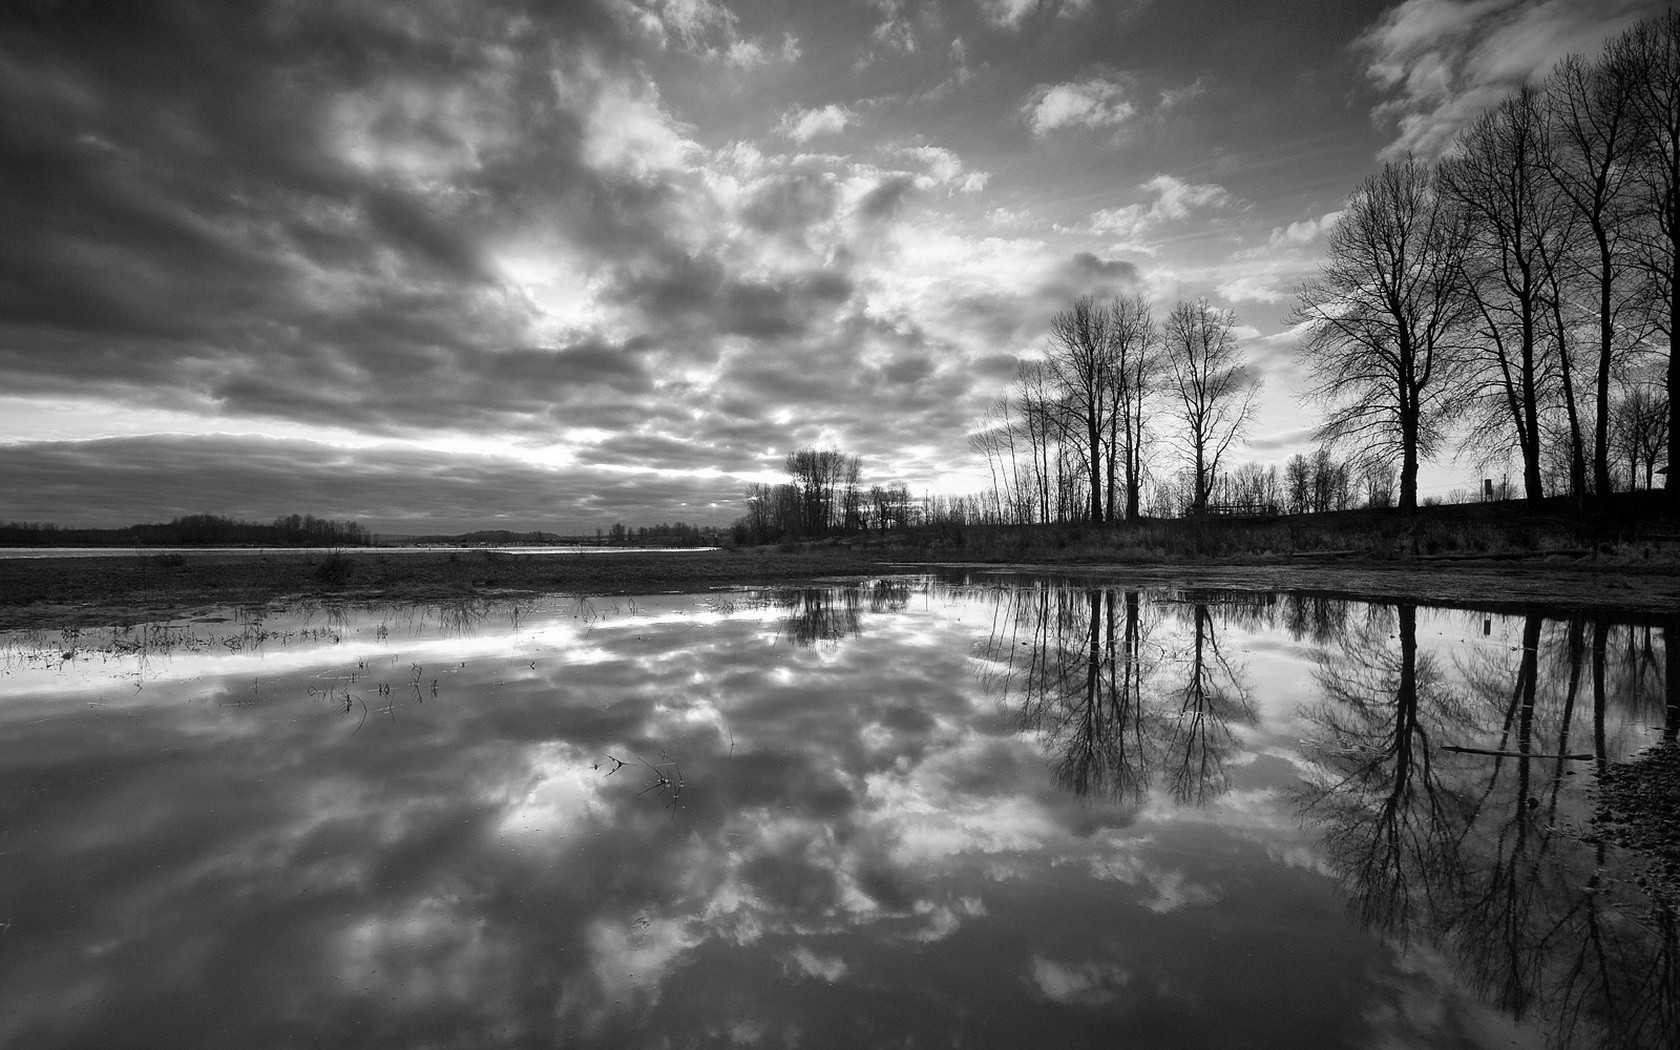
[1294,12,1680,507]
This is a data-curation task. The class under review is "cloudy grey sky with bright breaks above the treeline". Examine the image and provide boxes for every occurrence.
[0,0,1663,533]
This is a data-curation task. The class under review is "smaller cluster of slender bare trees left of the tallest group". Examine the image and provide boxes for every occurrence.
[969,294,1260,524]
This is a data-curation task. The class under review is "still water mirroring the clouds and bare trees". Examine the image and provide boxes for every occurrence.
[0,576,1680,1047]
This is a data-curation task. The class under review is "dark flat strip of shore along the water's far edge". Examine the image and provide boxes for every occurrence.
[0,546,1680,630]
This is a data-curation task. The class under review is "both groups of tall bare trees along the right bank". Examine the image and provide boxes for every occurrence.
[969,12,1680,524]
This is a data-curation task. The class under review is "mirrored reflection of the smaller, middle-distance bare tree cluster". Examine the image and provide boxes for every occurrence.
[979,586,1253,805]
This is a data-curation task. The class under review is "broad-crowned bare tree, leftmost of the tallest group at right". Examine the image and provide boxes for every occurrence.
[1292,158,1468,511]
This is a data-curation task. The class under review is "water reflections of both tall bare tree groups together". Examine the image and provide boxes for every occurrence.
[976,585,1680,1047]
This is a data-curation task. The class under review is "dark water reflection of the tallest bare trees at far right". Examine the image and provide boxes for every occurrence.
[1297,605,1680,1047]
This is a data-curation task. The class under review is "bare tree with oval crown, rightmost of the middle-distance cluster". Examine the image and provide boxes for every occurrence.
[1163,299,1260,512]
